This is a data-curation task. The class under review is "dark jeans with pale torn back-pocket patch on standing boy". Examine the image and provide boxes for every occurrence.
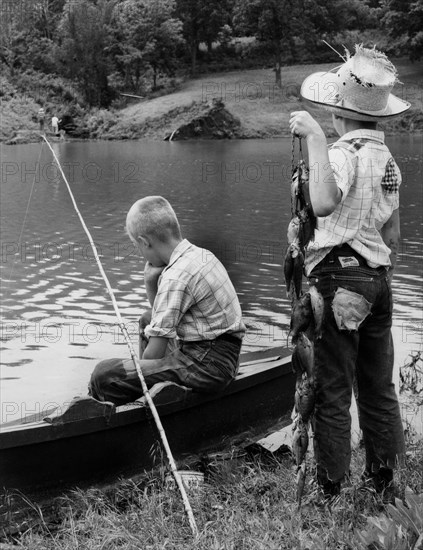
[309,245,405,484]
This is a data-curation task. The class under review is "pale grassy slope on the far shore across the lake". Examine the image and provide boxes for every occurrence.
[0,59,423,143]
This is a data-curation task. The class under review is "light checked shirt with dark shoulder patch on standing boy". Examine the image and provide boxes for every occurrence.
[305,130,401,276]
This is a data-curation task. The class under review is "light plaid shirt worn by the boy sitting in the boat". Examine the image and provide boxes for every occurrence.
[145,239,245,342]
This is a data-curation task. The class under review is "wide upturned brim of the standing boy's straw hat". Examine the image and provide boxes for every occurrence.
[300,72,411,122]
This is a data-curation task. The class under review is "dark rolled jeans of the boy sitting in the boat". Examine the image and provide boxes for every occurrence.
[88,337,242,405]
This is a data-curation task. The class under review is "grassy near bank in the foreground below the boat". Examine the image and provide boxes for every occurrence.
[5,442,423,550]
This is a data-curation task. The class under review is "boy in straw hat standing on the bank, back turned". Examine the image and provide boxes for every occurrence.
[290,46,410,497]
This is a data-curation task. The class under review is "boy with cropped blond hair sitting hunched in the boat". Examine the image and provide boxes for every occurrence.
[89,196,245,405]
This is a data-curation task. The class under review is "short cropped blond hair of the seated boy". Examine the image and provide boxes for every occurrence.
[126,196,182,242]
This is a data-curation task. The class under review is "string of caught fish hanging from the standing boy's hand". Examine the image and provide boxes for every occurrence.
[284,135,324,507]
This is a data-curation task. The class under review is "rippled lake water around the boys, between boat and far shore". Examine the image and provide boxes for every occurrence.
[0,136,423,430]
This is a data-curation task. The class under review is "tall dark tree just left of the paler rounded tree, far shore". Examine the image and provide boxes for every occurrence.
[59,0,115,107]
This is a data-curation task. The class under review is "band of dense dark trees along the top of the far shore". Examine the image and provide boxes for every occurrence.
[0,0,423,110]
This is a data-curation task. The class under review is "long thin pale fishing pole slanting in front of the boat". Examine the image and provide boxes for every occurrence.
[41,135,198,537]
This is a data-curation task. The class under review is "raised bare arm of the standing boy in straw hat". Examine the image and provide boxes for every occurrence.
[289,111,342,217]
